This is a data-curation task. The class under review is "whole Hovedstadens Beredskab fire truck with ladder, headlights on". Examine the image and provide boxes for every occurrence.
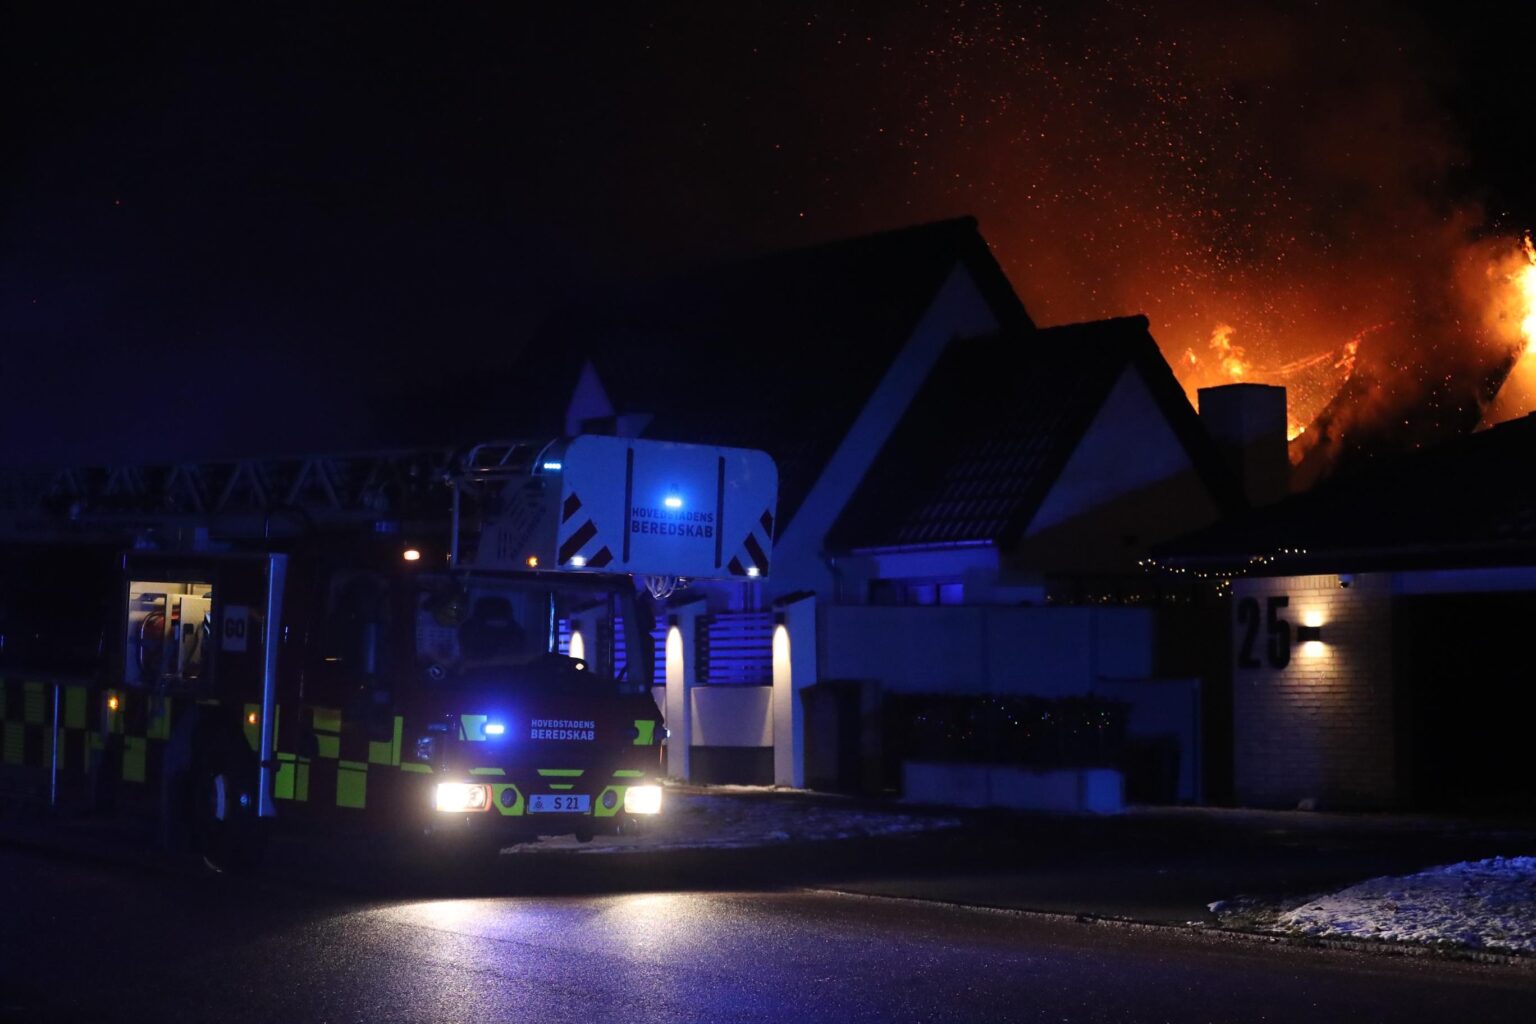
[0,436,777,867]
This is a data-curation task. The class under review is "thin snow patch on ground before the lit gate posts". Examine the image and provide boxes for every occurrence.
[513,786,960,855]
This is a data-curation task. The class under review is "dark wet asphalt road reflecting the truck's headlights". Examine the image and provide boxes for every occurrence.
[0,849,1536,1024]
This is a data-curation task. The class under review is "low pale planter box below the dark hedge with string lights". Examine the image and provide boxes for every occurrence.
[902,761,1126,814]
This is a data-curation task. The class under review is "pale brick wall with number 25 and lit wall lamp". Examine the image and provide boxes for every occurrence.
[1232,574,1401,808]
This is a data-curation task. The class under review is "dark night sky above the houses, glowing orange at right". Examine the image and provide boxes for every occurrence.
[0,0,1536,462]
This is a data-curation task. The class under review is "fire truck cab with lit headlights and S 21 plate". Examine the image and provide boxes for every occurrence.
[287,562,667,841]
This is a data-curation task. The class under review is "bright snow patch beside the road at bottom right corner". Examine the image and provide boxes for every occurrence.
[1265,857,1536,953]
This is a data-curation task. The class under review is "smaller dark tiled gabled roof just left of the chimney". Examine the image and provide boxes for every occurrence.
[828,316,1243,551]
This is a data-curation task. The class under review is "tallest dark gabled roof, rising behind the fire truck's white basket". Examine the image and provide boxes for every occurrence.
[522,218,1032,522]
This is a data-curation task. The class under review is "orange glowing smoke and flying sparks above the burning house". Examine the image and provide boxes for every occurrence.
[780,2,1536,445]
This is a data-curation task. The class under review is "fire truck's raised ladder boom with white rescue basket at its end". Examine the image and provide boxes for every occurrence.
[0,436,779,579]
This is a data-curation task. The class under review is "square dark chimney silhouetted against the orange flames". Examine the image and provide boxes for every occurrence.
[1200,384,1290,505]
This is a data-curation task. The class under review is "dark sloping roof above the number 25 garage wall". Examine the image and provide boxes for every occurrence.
[1155,416,1536,574]
